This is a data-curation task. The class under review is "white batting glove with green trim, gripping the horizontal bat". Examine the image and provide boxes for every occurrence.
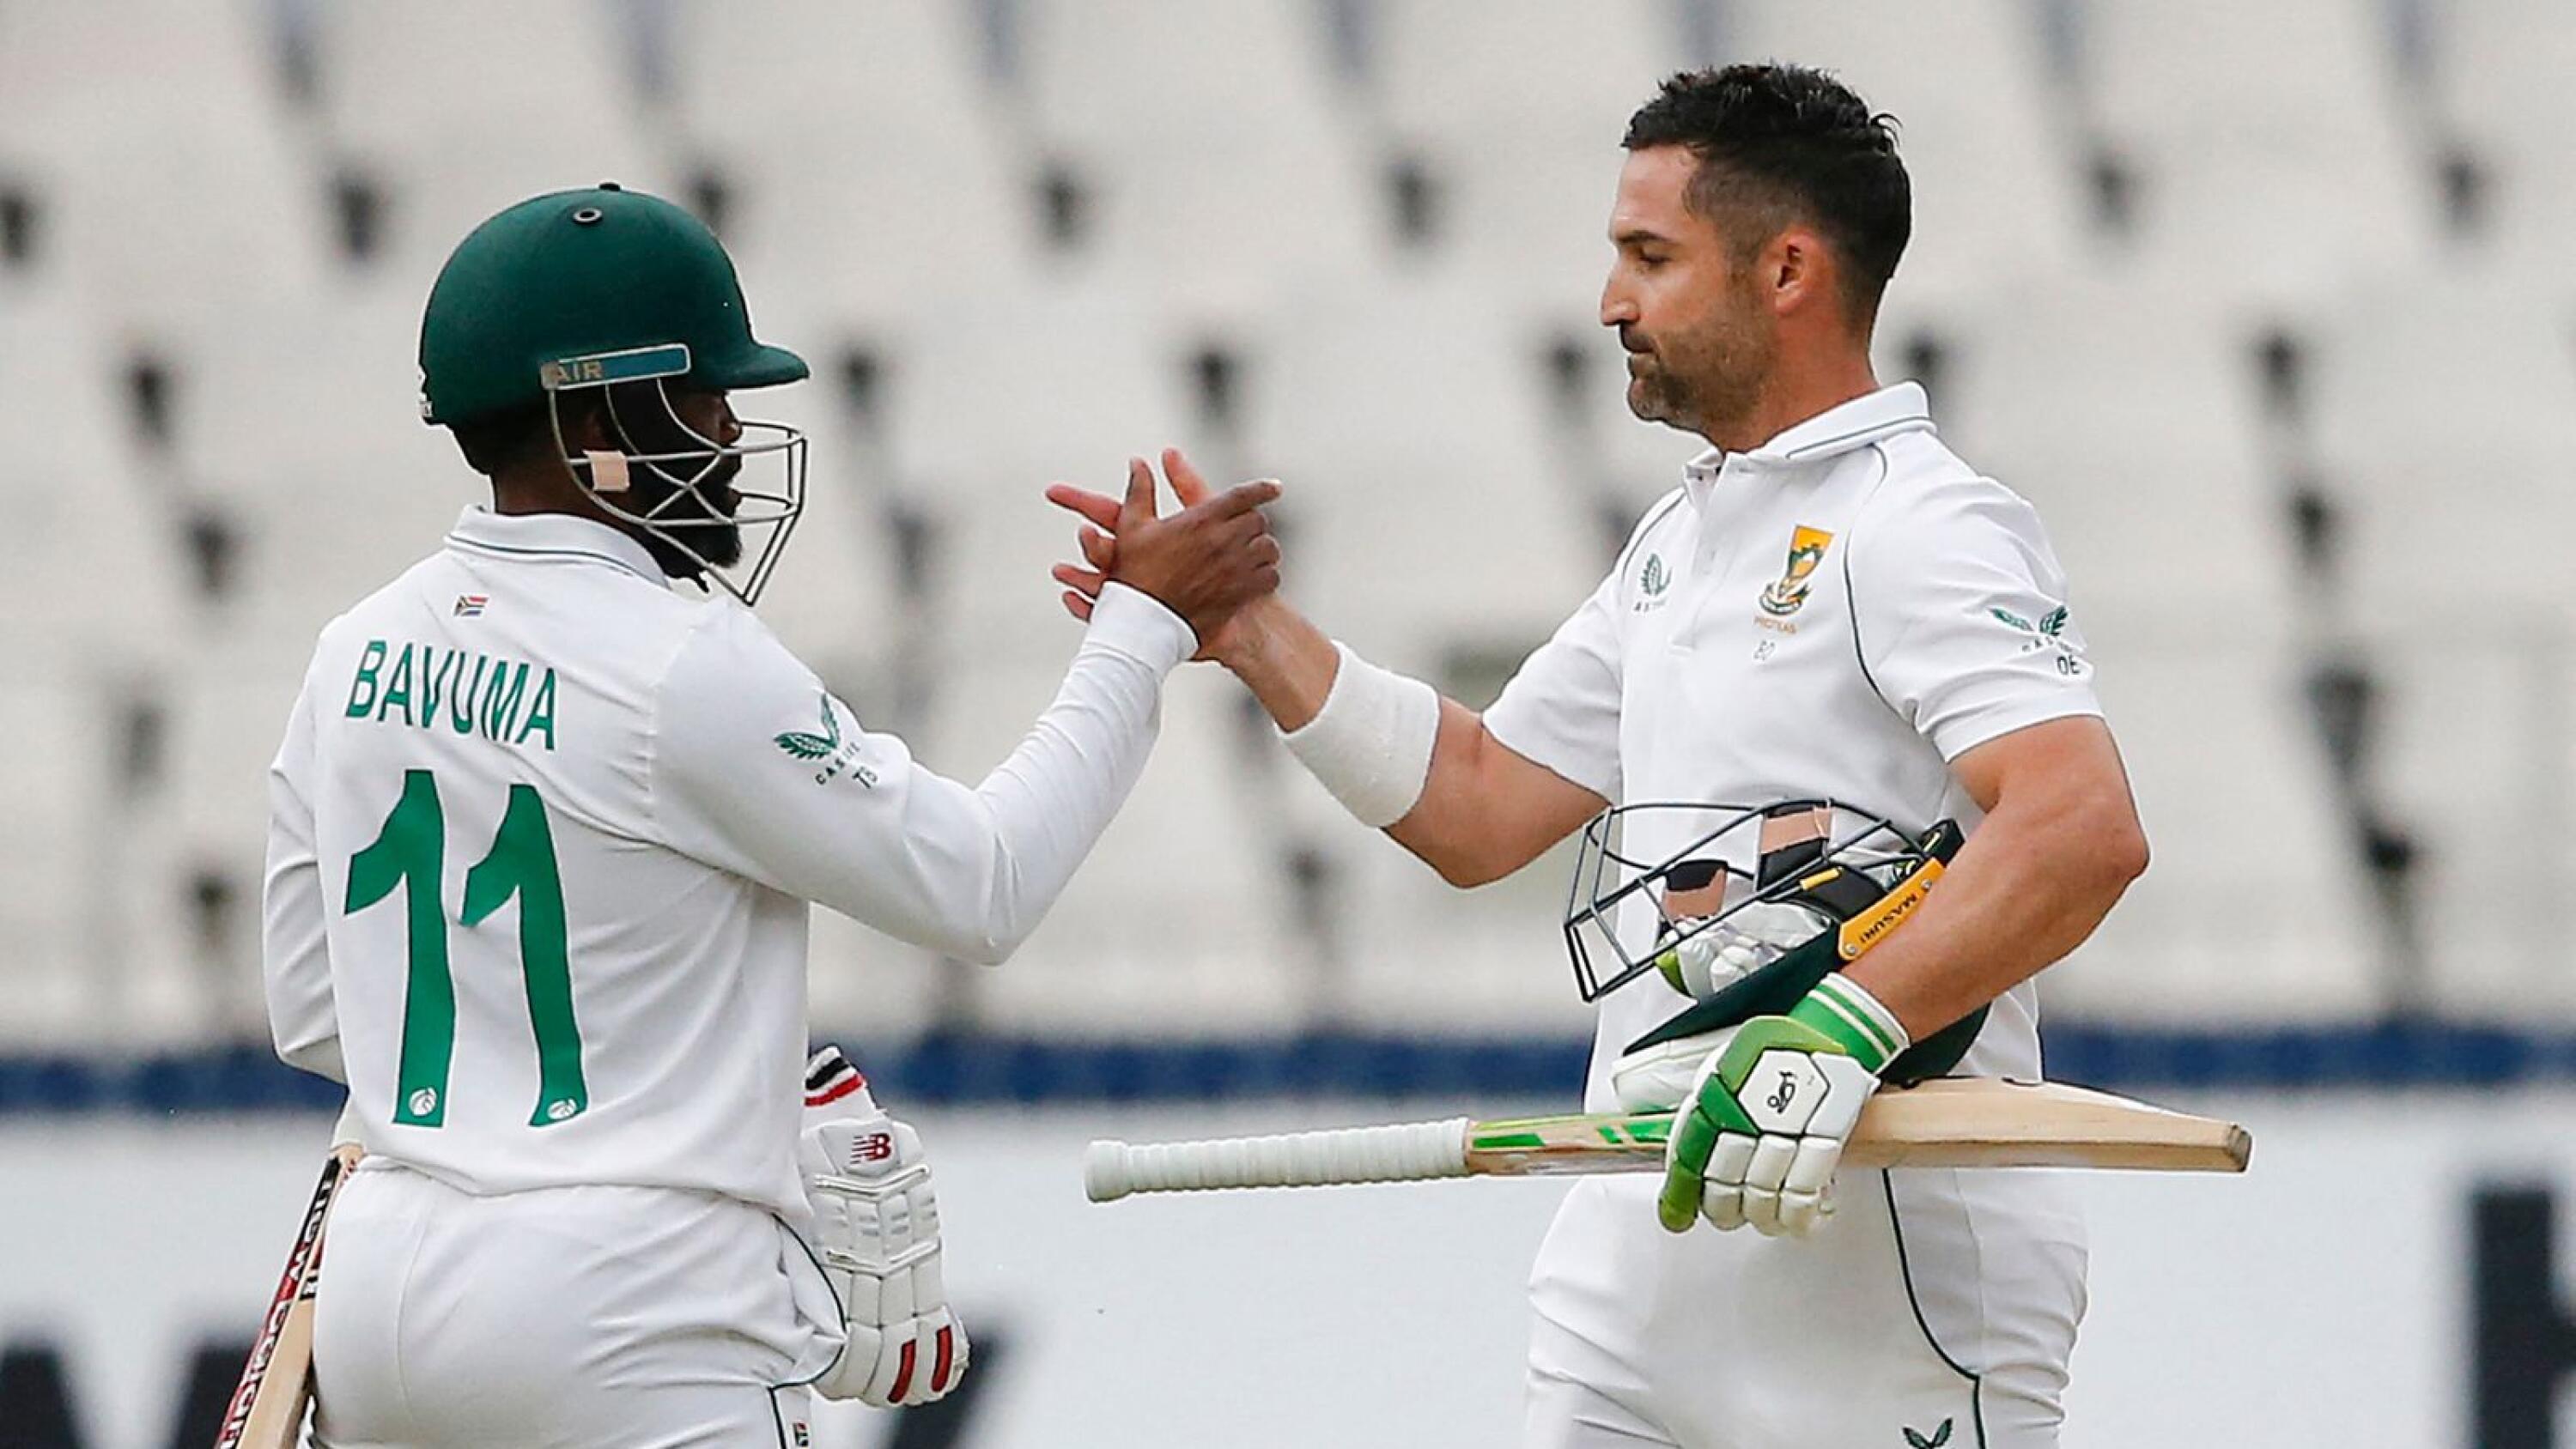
[1656,973,1911,1238]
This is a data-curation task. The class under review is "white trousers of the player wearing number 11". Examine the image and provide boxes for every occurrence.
[314,1158,840,1449]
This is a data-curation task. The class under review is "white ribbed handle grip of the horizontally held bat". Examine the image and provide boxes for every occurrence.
[1082,1117,1468,1202]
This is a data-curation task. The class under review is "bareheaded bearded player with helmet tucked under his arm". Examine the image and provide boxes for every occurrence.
[1054,64,2146,1449]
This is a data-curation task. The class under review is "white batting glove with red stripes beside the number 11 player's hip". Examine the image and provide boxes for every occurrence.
[796,1047,966,1408]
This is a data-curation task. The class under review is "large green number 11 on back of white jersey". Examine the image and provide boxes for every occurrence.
[345,769,590,1127]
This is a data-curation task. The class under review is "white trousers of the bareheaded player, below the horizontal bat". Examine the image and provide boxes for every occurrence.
[1522,1168,2084,1449]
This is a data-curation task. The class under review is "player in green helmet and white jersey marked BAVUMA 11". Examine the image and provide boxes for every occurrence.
[265,185,1278,1449]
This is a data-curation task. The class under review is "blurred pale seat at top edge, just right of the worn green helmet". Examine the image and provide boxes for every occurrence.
[675,0,1038,319]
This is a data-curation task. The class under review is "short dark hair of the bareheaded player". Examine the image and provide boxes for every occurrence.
[1620,64,1914,319]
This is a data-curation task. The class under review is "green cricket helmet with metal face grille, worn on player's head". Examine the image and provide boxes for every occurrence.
[420,183,806,603]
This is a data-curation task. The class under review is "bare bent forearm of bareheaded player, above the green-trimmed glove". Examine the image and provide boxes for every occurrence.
[1847,800,2146,1042]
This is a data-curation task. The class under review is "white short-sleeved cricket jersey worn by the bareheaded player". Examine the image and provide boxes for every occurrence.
[1484,384,2102,1112]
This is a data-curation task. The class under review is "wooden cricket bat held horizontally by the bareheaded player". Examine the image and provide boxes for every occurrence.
[1082,1076,2254,1202]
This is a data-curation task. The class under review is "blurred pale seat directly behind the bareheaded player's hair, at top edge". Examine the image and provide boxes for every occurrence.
[1721,0,2084,311]
